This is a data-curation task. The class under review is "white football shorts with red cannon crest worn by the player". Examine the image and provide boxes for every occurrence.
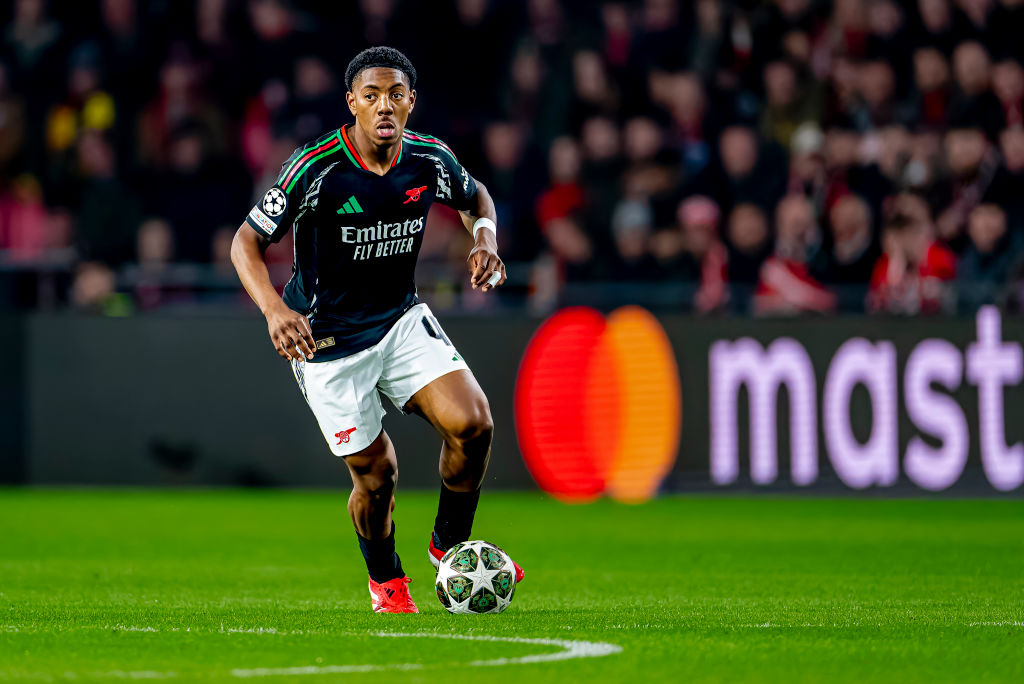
[292,303,469,457]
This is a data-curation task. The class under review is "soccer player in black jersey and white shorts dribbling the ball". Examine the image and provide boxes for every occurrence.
[231,47,523,612]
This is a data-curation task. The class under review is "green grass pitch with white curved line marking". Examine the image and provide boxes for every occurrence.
[0,489,1024,684]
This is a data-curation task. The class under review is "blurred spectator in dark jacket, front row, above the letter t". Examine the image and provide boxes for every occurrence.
[956,204,1024,312]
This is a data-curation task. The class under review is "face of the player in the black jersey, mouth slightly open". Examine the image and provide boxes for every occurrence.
[346,67,416,145]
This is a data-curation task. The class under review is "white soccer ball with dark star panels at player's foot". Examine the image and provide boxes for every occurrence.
[434,541,515,613]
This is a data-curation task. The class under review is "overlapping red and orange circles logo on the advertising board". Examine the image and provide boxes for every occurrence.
[515,306,682,502]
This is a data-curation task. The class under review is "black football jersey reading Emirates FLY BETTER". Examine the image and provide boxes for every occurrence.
[247,127,476,361]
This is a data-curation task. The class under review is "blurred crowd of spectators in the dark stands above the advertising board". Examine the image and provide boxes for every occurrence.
[6,0,1024,314]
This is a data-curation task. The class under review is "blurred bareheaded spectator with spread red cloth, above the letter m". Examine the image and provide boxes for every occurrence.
[754,195,836,315]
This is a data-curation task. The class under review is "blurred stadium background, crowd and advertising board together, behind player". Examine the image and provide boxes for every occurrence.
[0,0,1024,501]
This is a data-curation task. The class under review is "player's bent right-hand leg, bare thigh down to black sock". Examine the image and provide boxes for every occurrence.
[407,371,494,551]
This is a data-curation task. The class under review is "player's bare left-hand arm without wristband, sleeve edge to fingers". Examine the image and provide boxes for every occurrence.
[231,223,316,359]
